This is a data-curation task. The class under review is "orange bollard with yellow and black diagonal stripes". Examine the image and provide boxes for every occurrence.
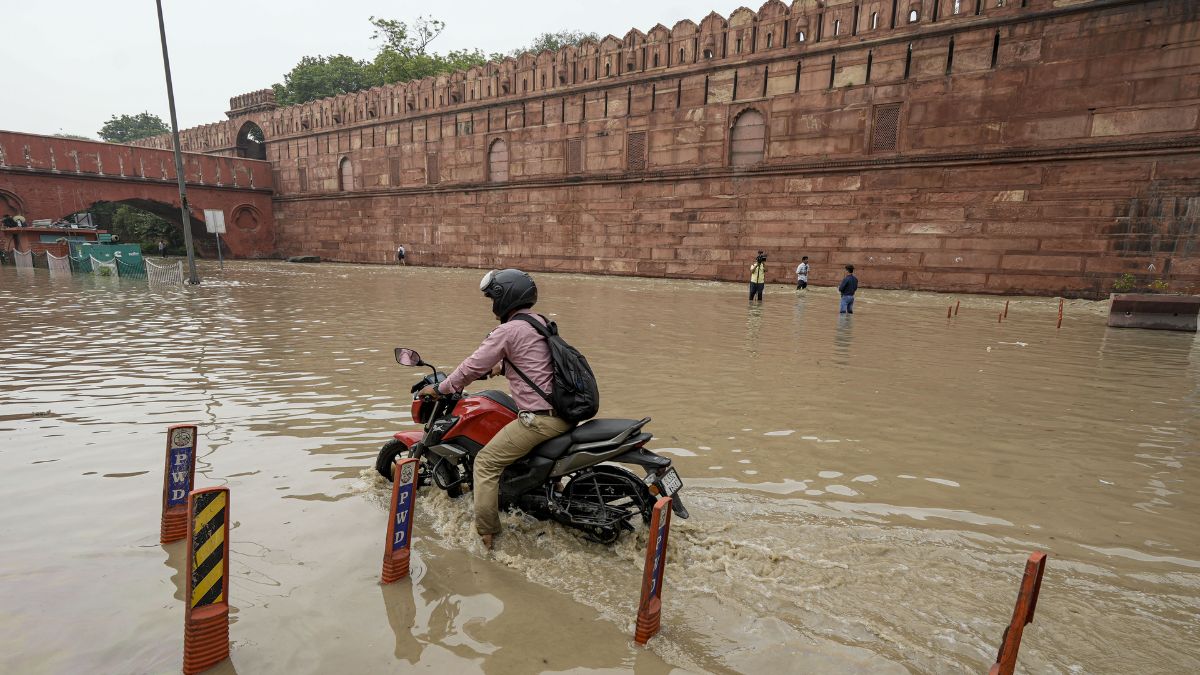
[184,488,229,675]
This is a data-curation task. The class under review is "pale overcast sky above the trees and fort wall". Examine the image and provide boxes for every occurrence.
[0,0,757,138]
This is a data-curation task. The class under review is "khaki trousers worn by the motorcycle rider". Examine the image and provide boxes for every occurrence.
[473,414,571,534]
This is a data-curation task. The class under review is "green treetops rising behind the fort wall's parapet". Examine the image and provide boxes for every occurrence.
[267,17,599,106]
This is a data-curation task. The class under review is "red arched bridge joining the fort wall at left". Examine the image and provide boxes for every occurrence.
[0,131,276,257]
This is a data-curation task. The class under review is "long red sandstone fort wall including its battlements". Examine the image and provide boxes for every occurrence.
[147,0,1200,294]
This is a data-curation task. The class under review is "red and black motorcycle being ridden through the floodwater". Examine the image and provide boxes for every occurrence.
[376,347,688,544]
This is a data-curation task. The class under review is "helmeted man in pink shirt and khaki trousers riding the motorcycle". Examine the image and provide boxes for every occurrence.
[420,269,571,549]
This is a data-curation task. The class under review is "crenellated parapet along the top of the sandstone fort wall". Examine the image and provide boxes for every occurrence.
[131,0,1080,154]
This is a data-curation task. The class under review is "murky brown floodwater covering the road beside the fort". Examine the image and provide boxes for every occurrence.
[0,262,1200,675]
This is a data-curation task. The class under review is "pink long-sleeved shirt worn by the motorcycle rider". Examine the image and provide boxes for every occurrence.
[438,310,554,410]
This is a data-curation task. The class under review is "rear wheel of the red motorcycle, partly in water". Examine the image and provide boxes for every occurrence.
[563,465,654,544]
